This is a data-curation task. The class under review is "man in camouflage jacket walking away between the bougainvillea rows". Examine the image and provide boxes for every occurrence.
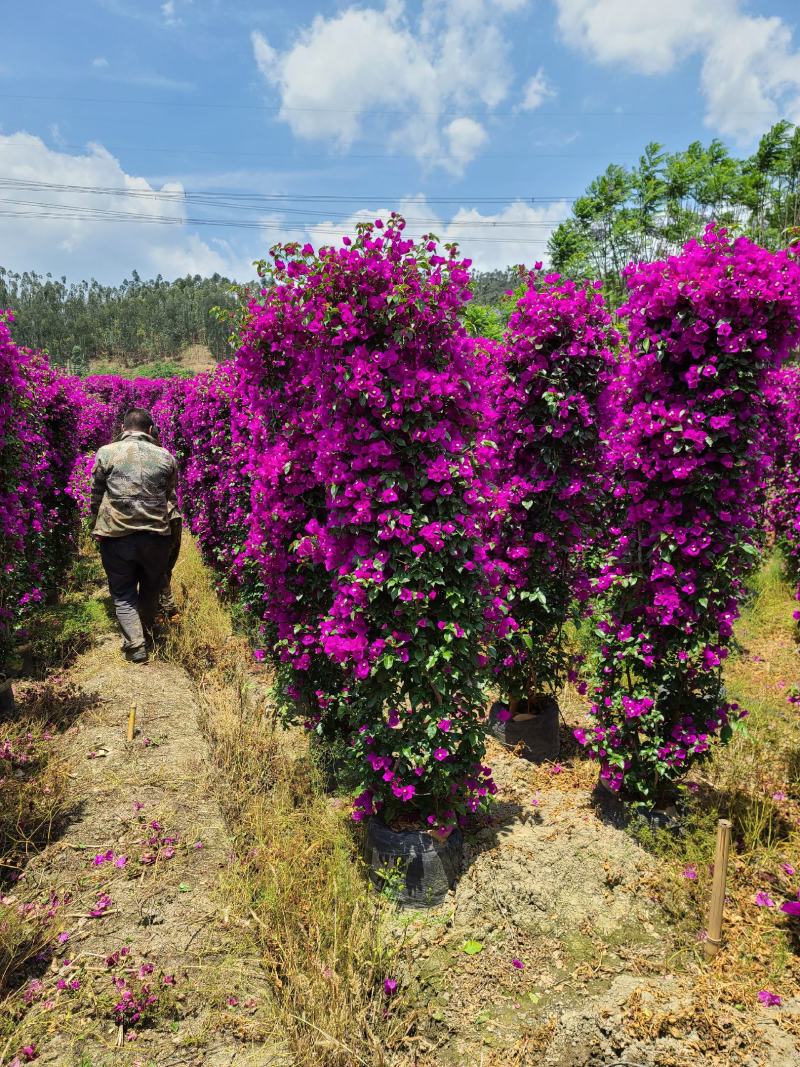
[91,408,179,663]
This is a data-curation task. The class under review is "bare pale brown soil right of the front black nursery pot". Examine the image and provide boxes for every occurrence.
[396,744,800,1067]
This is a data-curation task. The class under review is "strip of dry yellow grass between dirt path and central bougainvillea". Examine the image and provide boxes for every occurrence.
[169,541,403,1067]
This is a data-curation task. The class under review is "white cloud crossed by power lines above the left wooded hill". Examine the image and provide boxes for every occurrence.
[0,132,249,282]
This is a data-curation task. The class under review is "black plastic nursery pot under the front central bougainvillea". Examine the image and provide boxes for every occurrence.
[366,816,464,908]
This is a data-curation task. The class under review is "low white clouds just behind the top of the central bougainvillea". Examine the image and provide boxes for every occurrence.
[262,195,570,270]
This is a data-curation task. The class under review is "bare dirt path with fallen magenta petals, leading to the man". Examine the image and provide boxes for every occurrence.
[9,636,278,1067]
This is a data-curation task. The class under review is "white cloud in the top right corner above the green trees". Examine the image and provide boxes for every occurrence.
[556,0,800,143]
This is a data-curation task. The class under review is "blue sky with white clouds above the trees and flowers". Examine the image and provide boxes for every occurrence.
[0,0,800,283]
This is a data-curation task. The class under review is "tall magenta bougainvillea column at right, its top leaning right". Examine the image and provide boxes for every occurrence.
[576,227,800,802]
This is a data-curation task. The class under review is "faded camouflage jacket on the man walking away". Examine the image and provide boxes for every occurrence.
[92,430,180,537]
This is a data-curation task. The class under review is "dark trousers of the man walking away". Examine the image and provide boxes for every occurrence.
[97,532,173,652]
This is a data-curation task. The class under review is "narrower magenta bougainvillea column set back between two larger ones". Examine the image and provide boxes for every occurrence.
[493,273,620,699]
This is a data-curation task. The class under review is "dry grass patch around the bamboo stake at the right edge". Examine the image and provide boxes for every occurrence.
[618,558,800,1036]
